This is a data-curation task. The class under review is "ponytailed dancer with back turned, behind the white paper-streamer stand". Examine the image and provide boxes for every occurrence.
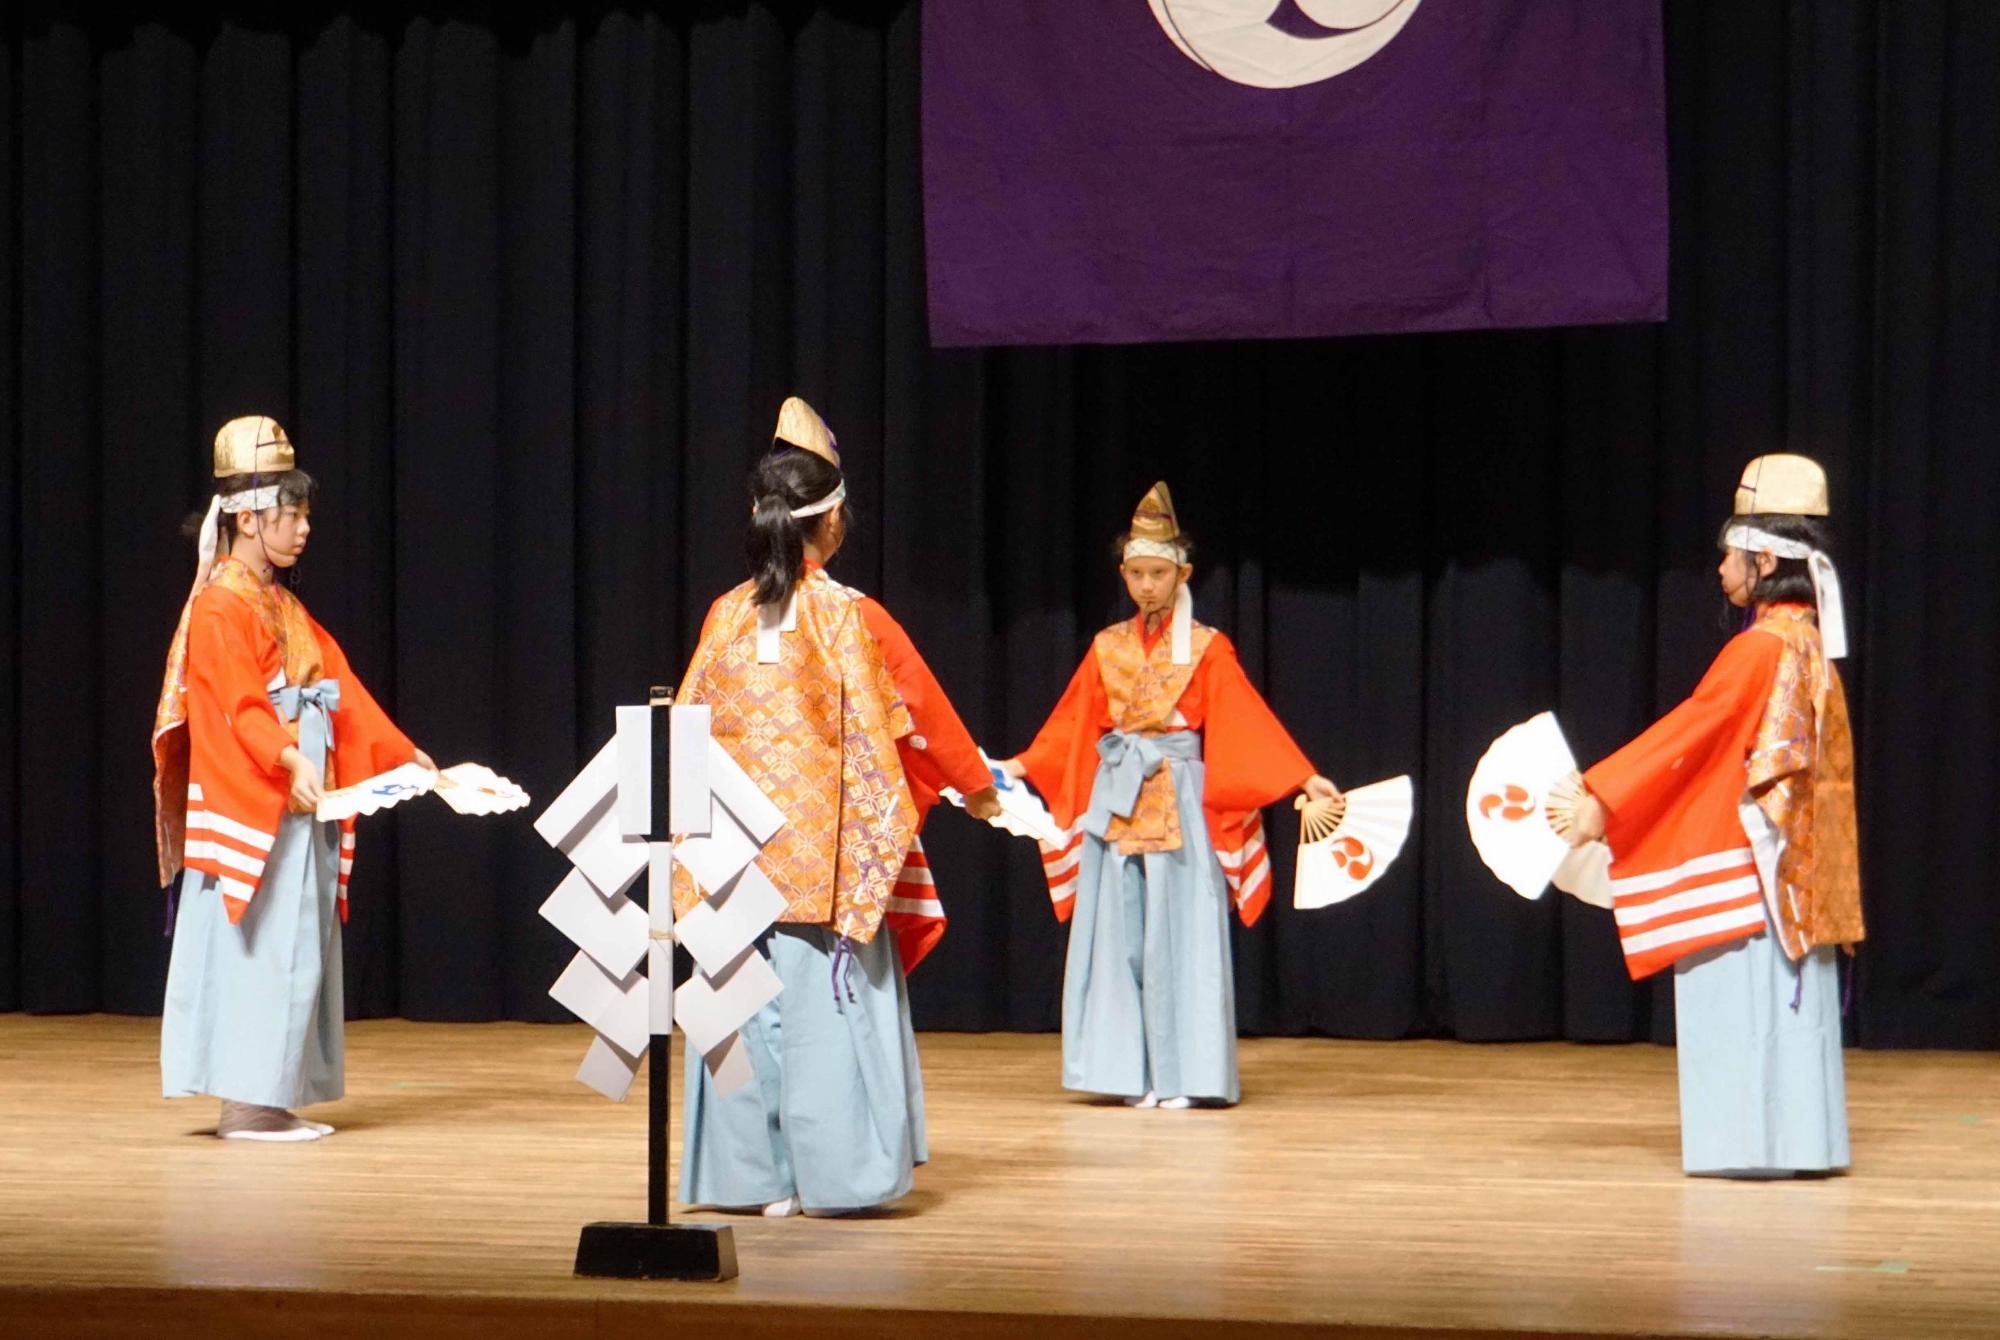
[674,396,1000,1218]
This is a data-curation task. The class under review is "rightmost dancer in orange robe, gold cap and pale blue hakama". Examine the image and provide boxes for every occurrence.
[1552,454,1862,1178]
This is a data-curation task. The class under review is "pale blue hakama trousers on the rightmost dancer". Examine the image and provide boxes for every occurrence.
[1674,926,1848,1178]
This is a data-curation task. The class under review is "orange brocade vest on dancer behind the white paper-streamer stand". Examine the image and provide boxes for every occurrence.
[674,568,920,942]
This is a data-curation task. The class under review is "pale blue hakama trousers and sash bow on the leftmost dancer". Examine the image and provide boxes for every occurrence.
[160,682,346,1108]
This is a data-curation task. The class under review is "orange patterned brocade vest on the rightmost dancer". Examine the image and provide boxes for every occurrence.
[1748,604,1862,960]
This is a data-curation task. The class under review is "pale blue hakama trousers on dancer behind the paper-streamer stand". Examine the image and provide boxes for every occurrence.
[680,924,930,1210]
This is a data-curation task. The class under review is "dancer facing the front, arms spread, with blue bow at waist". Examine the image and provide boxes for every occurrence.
[1000,482,1340,1108]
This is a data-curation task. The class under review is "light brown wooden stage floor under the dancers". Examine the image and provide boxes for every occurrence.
[0,1016,2000,1340]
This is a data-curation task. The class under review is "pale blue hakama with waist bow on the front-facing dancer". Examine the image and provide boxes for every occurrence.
[1062,732,1242,1102]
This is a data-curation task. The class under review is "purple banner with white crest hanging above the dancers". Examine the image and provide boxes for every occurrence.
[922,0,1666,344]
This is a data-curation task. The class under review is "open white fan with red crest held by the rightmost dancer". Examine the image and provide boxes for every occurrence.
[1466,712,1610,906]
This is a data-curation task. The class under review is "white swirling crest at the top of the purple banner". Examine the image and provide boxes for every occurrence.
[1148,0,1422,88]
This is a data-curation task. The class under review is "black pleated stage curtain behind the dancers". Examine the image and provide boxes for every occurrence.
[0,0,2000,1046]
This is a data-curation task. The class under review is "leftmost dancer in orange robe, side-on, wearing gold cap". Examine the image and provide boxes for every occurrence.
[152,416,436,1140]
